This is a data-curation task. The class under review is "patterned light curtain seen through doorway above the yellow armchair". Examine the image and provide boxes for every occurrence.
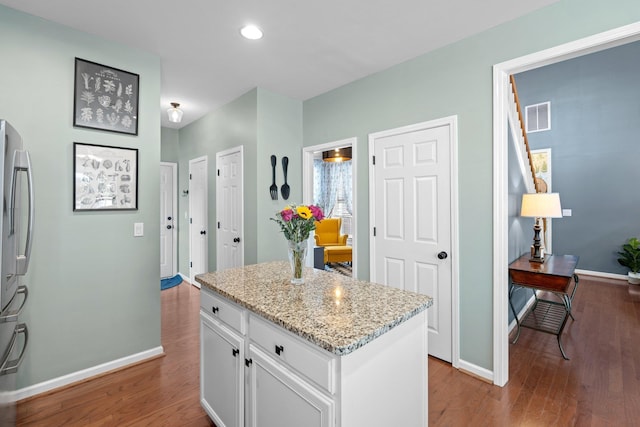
[313,159,353,217]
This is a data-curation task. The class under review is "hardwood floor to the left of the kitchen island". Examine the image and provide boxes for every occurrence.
[17,282,213,427]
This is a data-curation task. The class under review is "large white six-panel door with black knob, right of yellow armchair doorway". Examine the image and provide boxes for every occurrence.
[370,124,452,362]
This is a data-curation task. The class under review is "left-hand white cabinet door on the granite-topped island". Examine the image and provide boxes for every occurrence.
[200,312,244,427]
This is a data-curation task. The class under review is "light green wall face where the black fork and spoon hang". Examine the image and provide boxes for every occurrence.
[256,89,302,262]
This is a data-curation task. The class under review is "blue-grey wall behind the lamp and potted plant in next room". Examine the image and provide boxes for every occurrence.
[516,42,640,274]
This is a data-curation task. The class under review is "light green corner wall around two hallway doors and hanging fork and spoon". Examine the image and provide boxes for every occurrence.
[172,88,302,275]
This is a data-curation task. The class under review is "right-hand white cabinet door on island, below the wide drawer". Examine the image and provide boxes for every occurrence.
[248,344,335,427]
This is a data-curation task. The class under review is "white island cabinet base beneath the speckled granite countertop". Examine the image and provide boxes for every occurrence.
[200,287,428,427]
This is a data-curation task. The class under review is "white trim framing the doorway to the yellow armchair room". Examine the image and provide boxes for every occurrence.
[302,137,360,278]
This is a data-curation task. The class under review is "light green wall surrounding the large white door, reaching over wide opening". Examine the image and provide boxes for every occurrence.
[303,0,640,370]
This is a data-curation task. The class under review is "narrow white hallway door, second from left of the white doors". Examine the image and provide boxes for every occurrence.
[189,156,209,287]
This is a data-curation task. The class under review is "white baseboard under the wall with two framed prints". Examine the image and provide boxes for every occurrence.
[14,346,164,401]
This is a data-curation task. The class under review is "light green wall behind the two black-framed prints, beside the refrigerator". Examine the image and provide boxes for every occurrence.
[0,6,161,388]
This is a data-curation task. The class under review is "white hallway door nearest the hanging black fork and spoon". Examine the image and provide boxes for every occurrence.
[216,147,244,270]
